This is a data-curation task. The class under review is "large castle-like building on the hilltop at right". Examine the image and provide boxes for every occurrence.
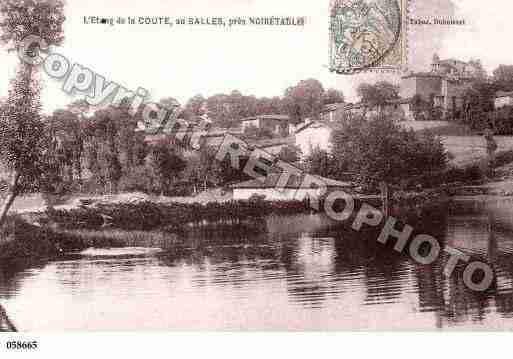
[400,55,485,118]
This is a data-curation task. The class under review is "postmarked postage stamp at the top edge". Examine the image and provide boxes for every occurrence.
[329,0,409,74]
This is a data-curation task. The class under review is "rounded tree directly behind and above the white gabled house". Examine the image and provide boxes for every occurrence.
[284,79,324,123]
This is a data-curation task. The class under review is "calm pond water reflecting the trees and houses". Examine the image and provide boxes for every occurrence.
[0,200,513,331]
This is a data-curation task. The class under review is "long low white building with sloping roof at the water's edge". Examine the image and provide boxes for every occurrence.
[231,173,352,201]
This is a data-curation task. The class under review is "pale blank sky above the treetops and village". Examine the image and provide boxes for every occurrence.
[0,0,513,113]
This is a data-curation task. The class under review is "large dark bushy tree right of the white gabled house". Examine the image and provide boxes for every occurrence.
[332,116,447,194]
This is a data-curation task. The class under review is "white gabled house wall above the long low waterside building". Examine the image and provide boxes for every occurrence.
[295,121,333,157]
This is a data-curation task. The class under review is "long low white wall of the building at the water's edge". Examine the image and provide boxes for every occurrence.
[233,188,323,201]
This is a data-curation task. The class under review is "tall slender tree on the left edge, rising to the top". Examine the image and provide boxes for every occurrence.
[0,0,65,226]
